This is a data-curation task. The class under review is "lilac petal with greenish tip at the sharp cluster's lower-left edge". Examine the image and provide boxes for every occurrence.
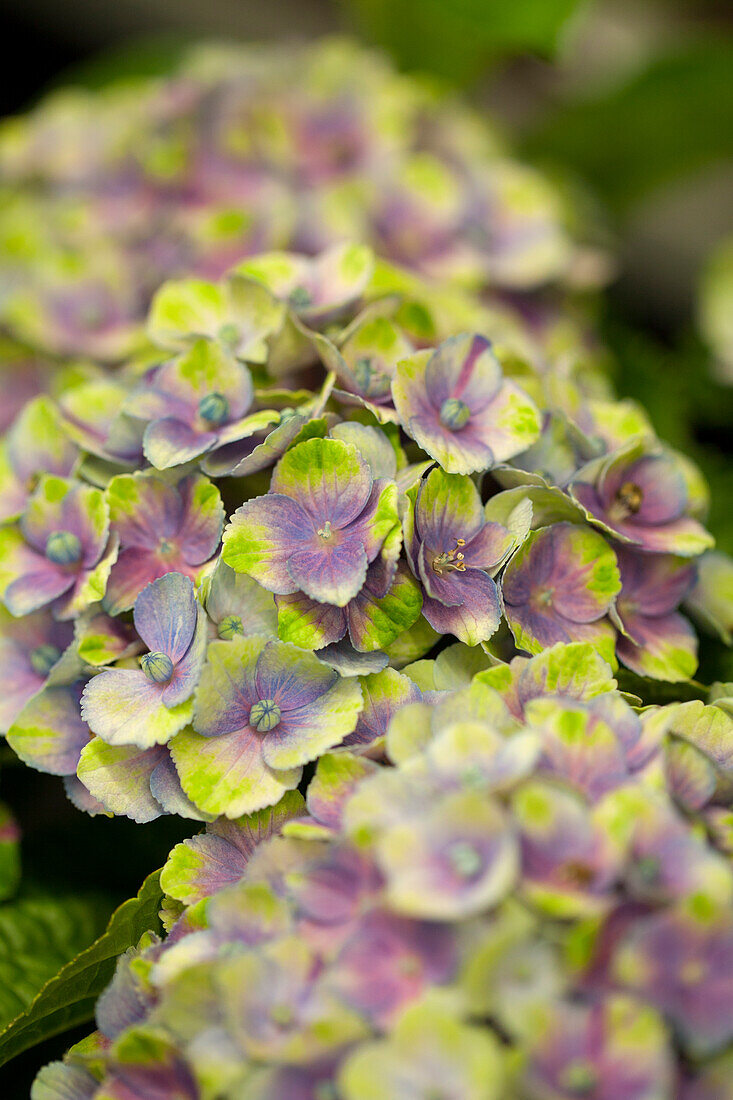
[8,684,89,776]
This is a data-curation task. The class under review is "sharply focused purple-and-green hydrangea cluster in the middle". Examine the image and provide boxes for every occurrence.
[0,243,724,822]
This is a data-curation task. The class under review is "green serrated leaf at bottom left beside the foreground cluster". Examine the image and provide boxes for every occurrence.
[0,871,163,1066]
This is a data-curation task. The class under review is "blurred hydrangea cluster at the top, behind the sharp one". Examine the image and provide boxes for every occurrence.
[0,41,605,361]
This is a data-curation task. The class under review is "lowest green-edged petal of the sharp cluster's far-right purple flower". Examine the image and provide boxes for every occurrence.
[616,609,698,682]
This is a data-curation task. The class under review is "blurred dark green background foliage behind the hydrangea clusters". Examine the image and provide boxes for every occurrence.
[0,0,733,1097]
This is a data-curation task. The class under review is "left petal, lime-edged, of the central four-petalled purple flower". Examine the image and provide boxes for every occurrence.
[222,493,316,595]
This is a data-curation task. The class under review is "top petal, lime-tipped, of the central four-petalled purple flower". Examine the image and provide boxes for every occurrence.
[270,438,372,530]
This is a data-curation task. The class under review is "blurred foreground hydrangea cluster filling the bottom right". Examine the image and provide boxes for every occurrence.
[32,642,733,1100]
